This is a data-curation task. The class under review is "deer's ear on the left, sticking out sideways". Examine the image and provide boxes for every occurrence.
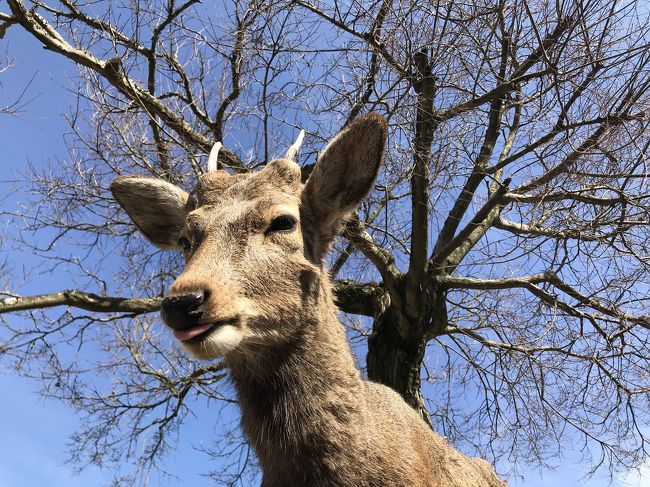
[111,176,189,250]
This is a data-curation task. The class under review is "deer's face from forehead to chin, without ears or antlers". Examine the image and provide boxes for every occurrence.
[154,159,312,358]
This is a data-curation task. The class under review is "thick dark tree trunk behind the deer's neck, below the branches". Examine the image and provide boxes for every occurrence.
[366,309,431,425]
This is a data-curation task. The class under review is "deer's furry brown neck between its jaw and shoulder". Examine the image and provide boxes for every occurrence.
[229,295,364,482]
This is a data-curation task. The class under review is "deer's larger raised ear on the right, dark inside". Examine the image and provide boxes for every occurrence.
[301,113,388,252]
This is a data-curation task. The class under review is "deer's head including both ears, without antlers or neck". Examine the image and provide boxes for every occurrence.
[111,115,386,359]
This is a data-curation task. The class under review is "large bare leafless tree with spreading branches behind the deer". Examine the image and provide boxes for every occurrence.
[0,0,650,484]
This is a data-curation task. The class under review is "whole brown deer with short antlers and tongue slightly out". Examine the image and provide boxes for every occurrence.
[110,114,506,487]
